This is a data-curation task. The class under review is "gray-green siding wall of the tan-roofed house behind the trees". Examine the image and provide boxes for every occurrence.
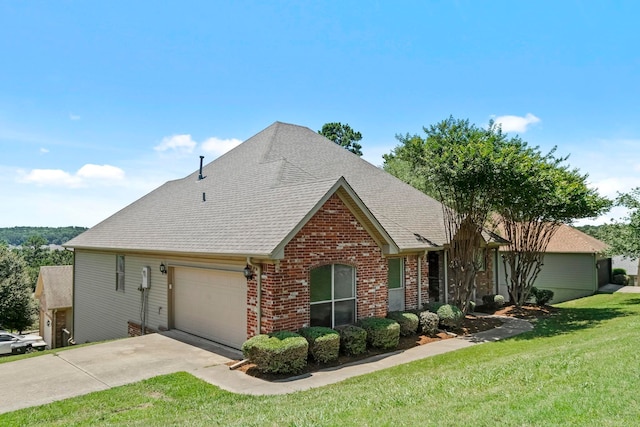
[498,253,598,304]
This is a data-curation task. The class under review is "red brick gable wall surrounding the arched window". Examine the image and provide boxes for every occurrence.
[247,195,390,336]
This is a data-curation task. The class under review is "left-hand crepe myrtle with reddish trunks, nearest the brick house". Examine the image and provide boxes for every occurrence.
[383,117,509,312]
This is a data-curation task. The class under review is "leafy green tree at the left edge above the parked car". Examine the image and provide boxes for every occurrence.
[0,245,35,332]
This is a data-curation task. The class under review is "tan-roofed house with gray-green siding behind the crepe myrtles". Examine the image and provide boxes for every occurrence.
[497,225,611,303]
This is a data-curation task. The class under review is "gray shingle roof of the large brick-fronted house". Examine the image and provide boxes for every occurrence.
[66,122,446,255]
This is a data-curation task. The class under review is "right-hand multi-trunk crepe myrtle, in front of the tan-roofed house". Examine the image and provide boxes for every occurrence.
[492,145,611,305]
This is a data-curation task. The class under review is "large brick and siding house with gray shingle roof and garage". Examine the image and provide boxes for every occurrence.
[66,122,504,348]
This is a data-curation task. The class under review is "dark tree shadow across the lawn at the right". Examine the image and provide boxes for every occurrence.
[512,308,628,340]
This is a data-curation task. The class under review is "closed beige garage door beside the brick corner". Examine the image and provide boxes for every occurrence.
[173,267,247,348]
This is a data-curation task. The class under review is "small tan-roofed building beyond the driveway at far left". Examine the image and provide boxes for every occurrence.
[35,265,73,348]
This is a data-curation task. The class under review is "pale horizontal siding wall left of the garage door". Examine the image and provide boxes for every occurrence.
[73,250,168,343]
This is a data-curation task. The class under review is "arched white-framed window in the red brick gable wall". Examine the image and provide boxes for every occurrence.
[311,264,356,328]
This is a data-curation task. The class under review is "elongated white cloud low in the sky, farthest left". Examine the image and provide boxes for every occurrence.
[18,164,125,188]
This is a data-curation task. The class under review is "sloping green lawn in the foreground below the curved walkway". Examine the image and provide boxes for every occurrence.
[0,294,640,426]
